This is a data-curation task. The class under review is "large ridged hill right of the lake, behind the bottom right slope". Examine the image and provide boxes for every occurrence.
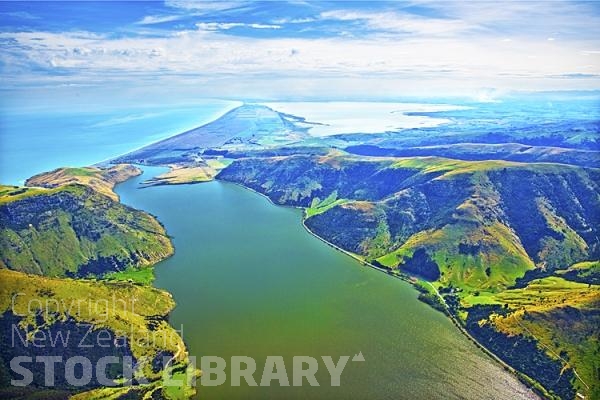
[218,153,600,278]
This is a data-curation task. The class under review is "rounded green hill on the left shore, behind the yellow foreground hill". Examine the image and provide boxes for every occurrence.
[0,184,173,276]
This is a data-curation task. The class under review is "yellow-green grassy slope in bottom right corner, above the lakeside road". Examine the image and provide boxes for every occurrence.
[474,276,600,399]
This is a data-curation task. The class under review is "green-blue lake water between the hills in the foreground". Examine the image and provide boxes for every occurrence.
[117,169,535,400]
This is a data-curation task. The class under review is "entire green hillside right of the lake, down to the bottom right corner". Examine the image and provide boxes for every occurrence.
[217,151,600,399]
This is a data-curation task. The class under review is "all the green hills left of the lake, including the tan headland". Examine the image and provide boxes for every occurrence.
[0,165,193,399]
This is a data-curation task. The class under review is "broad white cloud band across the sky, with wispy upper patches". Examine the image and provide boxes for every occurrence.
[0,2,600,97]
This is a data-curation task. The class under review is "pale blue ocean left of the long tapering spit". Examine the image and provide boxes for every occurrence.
[0,100,239,185]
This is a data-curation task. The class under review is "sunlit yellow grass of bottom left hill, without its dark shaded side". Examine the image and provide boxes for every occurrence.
[0,270,199,398]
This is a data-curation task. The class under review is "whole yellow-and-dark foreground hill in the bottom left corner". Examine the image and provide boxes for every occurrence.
[0,269,198,399]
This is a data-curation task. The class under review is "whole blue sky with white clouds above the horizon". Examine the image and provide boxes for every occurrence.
[0,0,600,107]
